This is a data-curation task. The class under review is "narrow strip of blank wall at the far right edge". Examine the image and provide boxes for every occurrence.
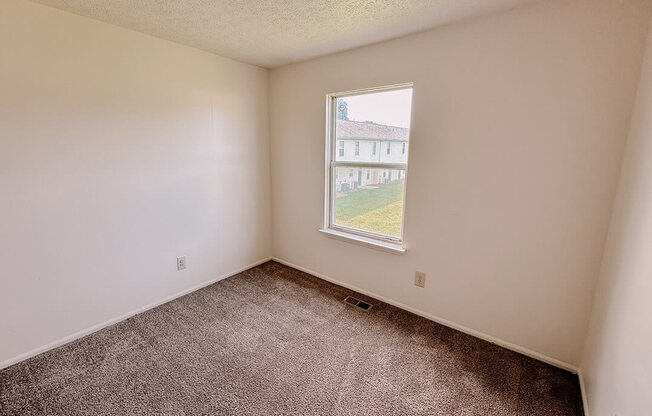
[582,13,652,416]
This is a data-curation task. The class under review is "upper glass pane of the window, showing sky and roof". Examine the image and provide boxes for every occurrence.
[335,88,412,163]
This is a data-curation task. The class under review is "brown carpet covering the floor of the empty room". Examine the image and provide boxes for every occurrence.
[0,262,582,416]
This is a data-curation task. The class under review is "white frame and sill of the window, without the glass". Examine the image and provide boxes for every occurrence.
[321,82,414,254]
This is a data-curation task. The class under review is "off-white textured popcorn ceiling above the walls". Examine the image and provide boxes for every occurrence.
[34,0,532,67]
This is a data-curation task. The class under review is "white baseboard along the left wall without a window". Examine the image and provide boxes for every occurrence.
[0,257,272,370]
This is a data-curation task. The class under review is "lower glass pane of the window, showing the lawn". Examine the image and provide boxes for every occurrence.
[333,167,405,237]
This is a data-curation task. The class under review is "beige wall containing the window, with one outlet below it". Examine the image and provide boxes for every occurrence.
[270,0,650,367]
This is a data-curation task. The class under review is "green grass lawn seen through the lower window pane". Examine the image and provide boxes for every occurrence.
[335,182,403,237]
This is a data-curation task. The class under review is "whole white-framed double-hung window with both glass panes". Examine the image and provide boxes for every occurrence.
[324,84,413,251]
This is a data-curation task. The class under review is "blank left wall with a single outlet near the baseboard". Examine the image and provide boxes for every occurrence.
[0,0,271,364]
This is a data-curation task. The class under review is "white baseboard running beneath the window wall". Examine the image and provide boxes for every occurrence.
[272,257,579,374]
